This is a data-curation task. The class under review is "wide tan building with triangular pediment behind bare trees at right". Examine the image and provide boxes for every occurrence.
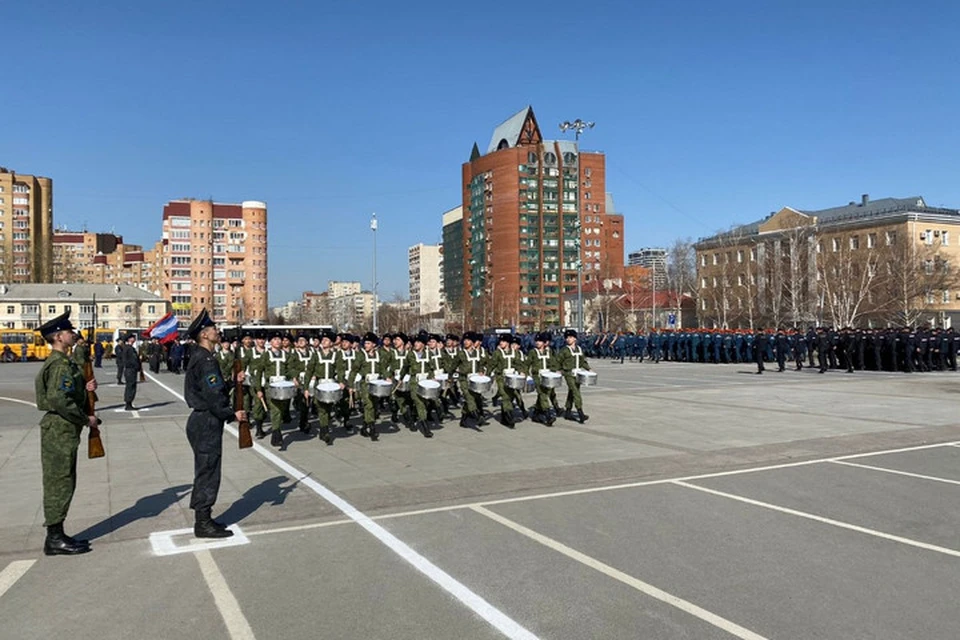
[695,195,960,328]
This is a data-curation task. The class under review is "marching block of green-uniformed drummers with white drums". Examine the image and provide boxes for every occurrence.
[216,330,596,446]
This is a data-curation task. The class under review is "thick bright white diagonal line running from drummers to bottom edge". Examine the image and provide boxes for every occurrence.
[148,376,537,640]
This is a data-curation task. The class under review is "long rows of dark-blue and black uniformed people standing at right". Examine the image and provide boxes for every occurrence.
[568,327,960,373]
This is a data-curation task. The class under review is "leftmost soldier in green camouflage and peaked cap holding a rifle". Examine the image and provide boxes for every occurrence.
[34,311,98,556]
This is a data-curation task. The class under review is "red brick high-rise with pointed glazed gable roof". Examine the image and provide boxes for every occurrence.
[462,107,624,330]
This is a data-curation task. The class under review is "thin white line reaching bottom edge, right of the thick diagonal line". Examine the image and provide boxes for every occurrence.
[471,506,765,640]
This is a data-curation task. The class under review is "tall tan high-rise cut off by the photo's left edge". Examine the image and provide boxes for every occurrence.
[0,167,53,283]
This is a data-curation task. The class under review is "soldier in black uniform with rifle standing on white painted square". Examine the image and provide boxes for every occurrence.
[183,309,246,538]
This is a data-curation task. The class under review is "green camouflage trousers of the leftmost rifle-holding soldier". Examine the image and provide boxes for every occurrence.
[40,413,83,527]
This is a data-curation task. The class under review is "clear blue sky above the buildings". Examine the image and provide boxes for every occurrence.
[7,0,960,304]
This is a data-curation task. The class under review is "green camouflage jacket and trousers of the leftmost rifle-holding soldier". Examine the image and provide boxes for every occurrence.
[35,351,88,527]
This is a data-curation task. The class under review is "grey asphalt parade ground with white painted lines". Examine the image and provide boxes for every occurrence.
[0,361,960,640]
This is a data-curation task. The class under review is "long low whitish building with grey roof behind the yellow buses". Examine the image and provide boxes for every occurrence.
[0,284,171,329]
